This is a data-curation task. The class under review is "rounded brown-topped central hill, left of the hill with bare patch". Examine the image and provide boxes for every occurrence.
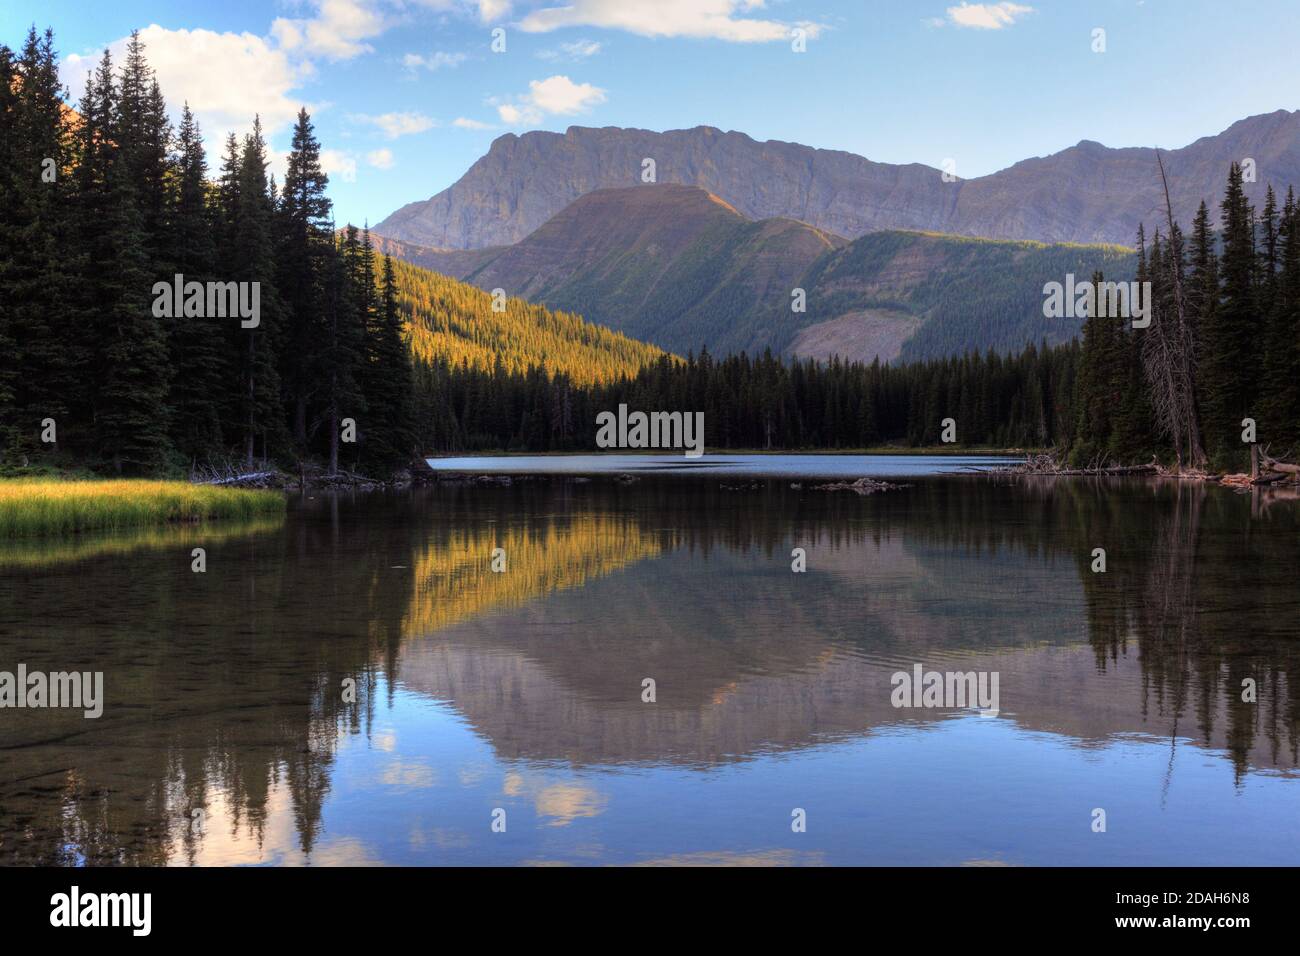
[465,185,844,351]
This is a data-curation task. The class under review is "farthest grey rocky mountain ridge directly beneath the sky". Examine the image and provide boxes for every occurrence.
[374,109,1300,248]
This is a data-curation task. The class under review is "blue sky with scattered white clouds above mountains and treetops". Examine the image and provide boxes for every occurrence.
[0,0,1300,225]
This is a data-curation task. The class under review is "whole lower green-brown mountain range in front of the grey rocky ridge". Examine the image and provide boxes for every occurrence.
[387,183,1135,362]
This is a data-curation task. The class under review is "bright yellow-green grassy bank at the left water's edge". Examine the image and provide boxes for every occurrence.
[0,479,285,537]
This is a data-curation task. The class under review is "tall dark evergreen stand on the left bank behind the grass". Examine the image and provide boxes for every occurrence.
[0,29,416,473]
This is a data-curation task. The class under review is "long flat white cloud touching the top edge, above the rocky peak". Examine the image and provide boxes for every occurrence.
[519,0,820,43]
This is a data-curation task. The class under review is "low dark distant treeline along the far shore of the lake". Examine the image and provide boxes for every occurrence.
[419,342,1080,451]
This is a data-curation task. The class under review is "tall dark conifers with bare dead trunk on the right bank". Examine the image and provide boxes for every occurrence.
[1074,163,1300,471]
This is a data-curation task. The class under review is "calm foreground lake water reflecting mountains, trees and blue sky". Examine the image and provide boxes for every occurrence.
[0,462,1300,865]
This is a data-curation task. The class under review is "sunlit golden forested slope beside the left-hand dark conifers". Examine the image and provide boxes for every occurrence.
[393,260,663,385]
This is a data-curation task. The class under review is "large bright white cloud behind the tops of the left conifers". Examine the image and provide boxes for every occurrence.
[60,23,309,145]
